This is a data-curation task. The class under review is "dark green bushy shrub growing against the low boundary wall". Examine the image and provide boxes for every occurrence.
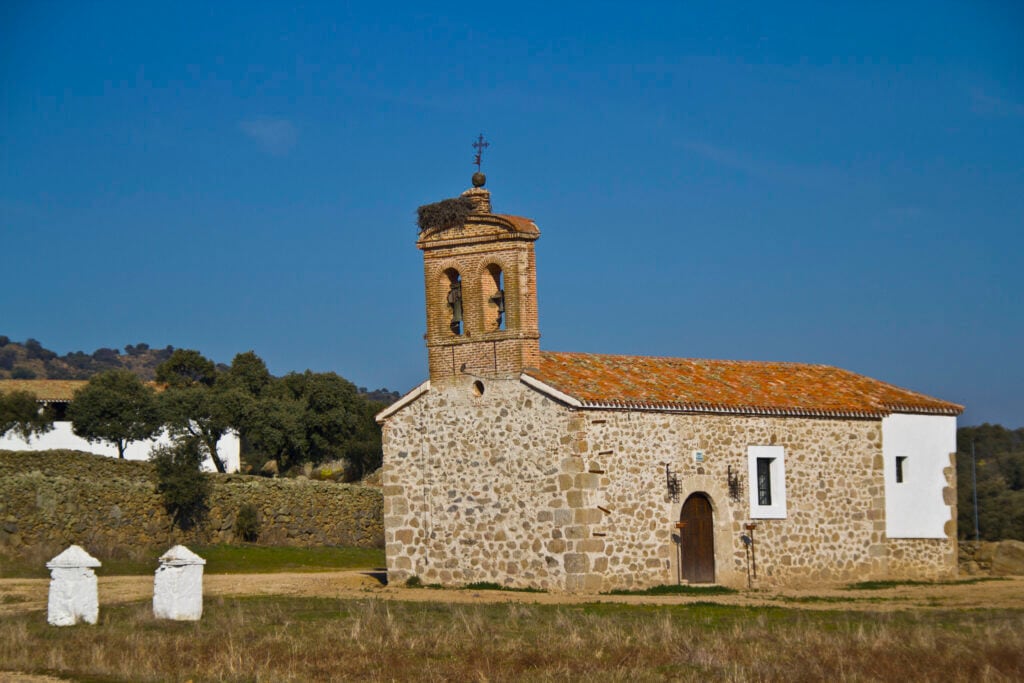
[150,438,211,530]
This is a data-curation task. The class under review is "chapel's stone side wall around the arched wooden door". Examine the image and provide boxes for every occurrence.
[589,412,955,588]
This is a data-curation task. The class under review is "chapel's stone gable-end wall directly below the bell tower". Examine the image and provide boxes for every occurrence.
[384,380,568,590]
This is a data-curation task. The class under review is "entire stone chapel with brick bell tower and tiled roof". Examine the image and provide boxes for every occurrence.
[377,174,963,592]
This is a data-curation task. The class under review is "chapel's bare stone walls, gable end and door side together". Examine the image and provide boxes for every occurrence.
[384,377,956,592]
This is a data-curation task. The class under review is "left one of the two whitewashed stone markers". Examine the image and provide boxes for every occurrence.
[46,546,100,626]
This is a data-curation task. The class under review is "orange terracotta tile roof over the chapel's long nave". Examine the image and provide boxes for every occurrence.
[526,351,964,418]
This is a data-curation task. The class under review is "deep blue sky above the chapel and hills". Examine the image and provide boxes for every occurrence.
[0,1,1024,427]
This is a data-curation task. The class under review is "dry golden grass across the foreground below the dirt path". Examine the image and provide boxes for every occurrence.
[0,597,1024,682]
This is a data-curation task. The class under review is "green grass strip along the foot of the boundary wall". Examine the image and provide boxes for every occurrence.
[0,545,384,579]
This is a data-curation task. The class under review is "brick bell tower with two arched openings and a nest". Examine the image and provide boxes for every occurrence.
[416,168,541,386]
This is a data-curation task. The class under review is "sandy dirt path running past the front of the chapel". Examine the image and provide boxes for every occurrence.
[0,571,1024,614]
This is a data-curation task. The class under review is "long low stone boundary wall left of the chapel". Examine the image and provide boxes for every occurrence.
[0,451,383,555]
